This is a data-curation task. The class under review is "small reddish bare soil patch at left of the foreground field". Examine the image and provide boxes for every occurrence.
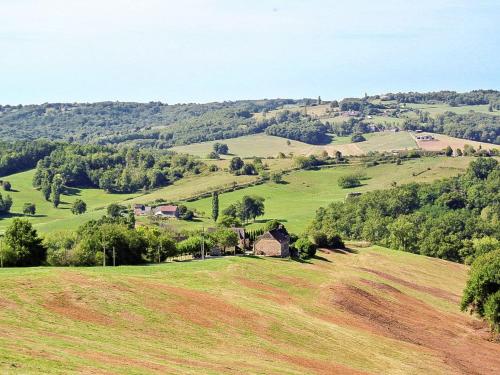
[44,292,113,325]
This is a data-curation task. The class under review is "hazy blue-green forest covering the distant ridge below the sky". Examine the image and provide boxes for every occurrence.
[0,90,500,148]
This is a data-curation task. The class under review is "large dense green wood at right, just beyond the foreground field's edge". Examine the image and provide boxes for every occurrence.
[311,158,500,262]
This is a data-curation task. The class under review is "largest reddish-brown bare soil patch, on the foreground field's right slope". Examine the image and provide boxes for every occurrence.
[330,280,500,375]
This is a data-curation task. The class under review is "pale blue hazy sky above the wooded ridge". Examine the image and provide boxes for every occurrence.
[0,0,500,105]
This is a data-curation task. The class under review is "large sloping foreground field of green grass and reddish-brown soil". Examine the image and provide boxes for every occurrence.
[0,247,500,375]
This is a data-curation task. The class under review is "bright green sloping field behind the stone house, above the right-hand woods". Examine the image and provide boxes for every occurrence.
[177,158,471,233]
